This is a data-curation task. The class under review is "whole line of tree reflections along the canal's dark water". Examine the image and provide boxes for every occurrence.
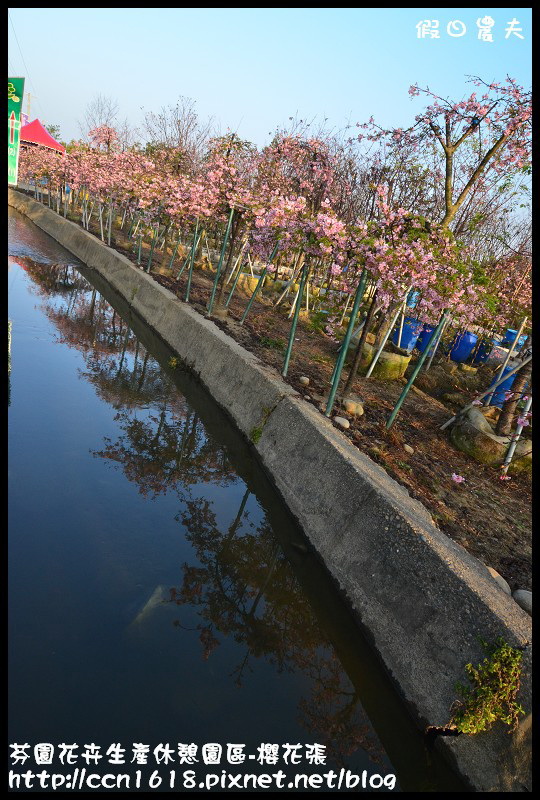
[21,253,382,767]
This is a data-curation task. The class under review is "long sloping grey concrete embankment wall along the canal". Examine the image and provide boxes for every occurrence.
[9,190,532,791]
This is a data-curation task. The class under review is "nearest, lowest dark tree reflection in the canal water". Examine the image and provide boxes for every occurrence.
[171,492,382,766]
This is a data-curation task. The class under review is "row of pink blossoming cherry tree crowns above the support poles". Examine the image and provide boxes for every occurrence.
[20,78,531,346]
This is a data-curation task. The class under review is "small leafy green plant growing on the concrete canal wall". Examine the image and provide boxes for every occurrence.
[448,636,525,734]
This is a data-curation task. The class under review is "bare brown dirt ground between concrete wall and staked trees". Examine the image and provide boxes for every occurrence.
[66,209,532,590]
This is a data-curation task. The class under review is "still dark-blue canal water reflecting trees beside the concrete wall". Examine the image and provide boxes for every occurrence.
[8,209,462,791]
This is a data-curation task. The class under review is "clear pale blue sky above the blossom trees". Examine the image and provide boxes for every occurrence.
[8,7,532,146]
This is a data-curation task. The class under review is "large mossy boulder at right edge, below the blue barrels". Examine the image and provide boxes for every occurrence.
[450,406,532,473]
